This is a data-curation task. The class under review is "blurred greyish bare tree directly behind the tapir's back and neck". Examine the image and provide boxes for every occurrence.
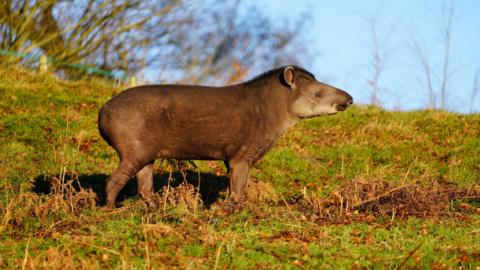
[163,1,310,84]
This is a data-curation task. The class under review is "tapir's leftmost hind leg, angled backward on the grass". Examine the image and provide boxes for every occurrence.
[105,160,148,208]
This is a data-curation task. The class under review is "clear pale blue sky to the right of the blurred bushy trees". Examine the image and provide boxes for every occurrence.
[256,0,480,113]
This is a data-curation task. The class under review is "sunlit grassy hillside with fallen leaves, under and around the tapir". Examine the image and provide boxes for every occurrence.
[0,68,480,269]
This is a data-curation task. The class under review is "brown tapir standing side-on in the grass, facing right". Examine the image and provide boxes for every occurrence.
[98,66,353,207]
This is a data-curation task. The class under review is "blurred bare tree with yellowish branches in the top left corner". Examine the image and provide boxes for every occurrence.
[0,0,181,75]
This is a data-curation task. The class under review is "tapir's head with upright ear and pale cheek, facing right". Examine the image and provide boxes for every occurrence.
[283,66,353,118]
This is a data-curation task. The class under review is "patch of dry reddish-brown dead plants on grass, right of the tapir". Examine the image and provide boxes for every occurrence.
[297,180,480,222]
